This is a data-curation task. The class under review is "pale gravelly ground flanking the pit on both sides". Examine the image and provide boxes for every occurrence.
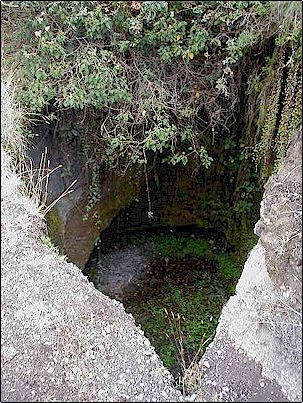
[1,133,302,401]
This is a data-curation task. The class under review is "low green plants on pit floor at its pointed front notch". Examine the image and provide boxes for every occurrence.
[127,271,229,375]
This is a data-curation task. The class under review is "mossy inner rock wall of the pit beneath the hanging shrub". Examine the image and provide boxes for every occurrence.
[29,127,233,269]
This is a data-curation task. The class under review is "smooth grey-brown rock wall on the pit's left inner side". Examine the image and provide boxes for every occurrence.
[29,132,142,269]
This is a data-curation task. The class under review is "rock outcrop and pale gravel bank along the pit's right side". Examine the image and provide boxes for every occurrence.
[197,134,302,401]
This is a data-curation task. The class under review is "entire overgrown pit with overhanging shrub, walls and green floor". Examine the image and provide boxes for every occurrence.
[4,2,302,400]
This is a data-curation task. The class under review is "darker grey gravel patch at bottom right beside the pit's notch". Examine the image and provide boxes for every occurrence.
[196,333,287,402]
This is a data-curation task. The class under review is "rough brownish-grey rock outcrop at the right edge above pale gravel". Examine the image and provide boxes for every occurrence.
[255,132,302,312]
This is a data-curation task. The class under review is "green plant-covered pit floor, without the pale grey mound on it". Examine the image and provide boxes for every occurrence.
[85,231,241,386]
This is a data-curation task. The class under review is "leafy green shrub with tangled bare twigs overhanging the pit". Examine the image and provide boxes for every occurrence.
[1,1,301,177]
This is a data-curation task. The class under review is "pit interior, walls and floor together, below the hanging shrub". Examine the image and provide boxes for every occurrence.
[24,117,261,389]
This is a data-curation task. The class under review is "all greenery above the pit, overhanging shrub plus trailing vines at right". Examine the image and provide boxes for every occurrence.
[1,1,301,216]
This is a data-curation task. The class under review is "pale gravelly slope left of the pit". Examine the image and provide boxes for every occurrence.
[1,149,184,402]
